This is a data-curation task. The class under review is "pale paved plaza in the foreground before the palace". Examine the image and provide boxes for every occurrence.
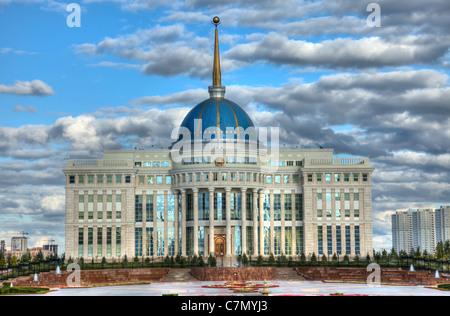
[31,281,450,296]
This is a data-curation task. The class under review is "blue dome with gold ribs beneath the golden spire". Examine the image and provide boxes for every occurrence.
[181,98,255,139]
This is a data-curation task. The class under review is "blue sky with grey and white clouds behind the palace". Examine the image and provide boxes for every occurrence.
[0,0,450,249]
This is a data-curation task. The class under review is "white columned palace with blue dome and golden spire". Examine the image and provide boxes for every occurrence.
[64,18,374,261]
